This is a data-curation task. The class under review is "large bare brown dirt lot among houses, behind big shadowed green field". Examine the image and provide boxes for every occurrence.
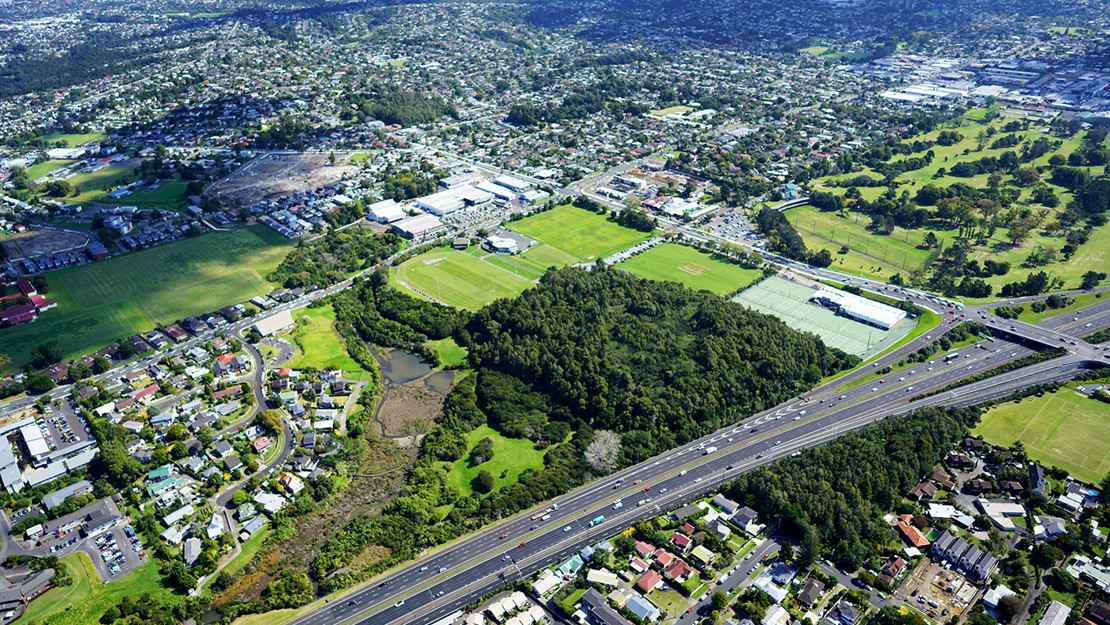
[205,154,357,206]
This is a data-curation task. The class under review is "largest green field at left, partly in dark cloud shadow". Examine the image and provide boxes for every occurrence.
[0,226,289,370]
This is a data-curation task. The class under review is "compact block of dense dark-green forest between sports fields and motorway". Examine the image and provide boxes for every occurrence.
[462,268,856,457]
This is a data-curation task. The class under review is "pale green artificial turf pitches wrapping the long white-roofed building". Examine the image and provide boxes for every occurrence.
[733,278,916,359]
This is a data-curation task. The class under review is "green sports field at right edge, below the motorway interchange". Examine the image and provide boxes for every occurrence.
[975,389,1110,484]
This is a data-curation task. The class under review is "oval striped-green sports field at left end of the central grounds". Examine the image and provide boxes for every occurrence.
[391,248,532,311]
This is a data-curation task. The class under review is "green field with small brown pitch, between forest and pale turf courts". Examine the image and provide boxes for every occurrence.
[617,243,763,295]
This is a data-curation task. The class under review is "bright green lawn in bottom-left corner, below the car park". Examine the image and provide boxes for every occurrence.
[20,552,170,625]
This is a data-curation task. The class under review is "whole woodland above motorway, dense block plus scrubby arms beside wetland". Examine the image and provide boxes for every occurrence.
[312,266,857,592]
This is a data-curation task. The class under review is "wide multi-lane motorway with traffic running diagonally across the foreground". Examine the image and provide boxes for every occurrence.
[293,315,1093,625]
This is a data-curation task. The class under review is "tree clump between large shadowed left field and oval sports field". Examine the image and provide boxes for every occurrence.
[266,228,401,289]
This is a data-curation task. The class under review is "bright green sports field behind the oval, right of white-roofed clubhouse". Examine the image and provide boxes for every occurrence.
[507,204,650,268]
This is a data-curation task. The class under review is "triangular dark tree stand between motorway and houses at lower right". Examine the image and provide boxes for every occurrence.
[724,407,979,569]
